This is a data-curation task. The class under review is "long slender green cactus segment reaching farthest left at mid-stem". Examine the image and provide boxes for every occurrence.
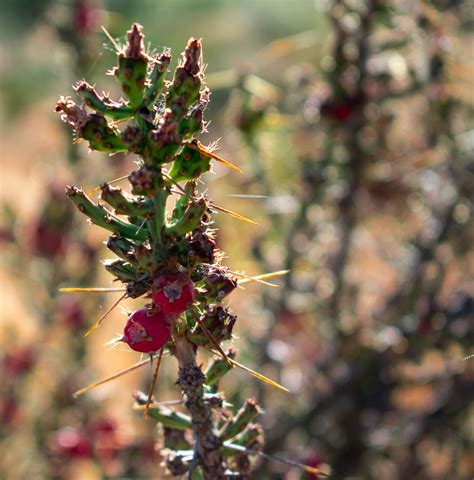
[66,186,148,241]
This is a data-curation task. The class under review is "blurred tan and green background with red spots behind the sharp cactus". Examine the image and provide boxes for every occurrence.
[0,0,474,480]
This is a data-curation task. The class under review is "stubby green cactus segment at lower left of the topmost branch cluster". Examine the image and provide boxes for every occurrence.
[80,113,128,153]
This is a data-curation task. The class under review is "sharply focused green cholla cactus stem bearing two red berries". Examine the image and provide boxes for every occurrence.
[56,24,308,479]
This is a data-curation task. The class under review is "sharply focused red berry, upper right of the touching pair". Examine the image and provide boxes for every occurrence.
[152,272,196,315]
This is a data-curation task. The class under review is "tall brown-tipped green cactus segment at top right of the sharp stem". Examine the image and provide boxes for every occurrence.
[166,38,202,119]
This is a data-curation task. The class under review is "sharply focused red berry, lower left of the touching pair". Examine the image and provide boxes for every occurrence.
[123,308,171,353]
